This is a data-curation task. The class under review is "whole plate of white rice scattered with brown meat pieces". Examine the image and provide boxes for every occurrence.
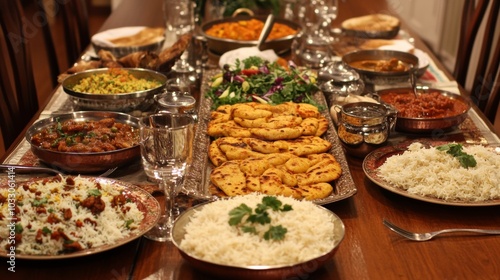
[0,176,160,260]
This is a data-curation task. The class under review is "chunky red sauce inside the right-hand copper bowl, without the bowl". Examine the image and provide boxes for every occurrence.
[380,92,467,118]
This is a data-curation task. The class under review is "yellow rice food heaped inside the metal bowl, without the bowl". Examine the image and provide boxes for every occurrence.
[72,68,161,94]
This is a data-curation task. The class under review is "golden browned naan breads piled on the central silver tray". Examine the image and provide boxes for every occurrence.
[207,102,342,200]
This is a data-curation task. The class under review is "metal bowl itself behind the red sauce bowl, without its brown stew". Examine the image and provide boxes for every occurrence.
[342,50,425,85]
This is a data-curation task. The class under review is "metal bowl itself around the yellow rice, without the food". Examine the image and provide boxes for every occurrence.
[62,68,167,112]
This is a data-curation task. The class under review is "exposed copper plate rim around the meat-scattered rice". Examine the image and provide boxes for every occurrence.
[0,177,161,260]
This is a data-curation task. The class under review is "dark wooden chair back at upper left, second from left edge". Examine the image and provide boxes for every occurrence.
[34,0,90,87]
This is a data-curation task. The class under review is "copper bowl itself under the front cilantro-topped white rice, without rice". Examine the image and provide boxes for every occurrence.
[172,202,345,280]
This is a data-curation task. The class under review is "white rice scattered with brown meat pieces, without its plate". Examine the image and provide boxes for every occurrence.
[0,176,144,256]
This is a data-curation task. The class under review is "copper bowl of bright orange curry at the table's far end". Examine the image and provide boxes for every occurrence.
[201,15,300,55]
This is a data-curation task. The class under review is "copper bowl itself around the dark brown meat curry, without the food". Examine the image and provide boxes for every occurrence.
[25,111,141,174]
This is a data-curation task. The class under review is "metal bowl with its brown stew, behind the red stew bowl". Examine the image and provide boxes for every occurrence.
[342,50,425,85]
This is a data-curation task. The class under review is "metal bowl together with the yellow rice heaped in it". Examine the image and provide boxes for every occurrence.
[62,68,167,112]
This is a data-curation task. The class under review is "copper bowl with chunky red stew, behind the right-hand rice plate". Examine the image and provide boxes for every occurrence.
[375,87,471,133]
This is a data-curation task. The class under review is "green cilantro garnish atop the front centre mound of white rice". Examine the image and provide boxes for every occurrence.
[229,196,293,240]
